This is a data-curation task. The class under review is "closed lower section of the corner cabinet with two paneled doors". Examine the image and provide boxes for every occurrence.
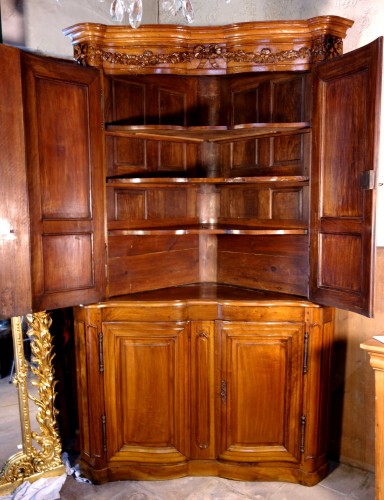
[75,296,333,485]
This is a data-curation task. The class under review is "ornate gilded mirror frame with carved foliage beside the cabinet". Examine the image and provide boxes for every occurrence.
[0,311,65,495]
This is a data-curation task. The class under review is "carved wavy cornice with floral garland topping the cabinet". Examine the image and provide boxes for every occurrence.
[63,16,353,75]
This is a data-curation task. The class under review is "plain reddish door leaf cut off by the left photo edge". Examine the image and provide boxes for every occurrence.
[0,45,32,318]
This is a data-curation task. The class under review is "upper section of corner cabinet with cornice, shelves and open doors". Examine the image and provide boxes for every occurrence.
[0,16,382,316]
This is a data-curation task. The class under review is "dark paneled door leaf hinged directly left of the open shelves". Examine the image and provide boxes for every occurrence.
[22,54,105,310]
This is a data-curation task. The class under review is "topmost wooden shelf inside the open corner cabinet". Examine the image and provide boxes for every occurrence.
[105,122,310,144]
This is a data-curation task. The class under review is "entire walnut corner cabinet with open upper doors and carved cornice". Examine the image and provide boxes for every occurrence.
[0,16,382,485]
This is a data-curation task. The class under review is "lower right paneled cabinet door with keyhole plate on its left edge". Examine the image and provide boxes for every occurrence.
[218,322,305,464]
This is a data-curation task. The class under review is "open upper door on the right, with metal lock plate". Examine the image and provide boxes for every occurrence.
[310,38,382,316]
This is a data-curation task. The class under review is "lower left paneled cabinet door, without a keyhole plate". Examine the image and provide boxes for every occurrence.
[103,322,190,466]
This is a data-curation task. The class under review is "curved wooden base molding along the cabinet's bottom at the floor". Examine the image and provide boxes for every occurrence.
[80,459,328,486]
